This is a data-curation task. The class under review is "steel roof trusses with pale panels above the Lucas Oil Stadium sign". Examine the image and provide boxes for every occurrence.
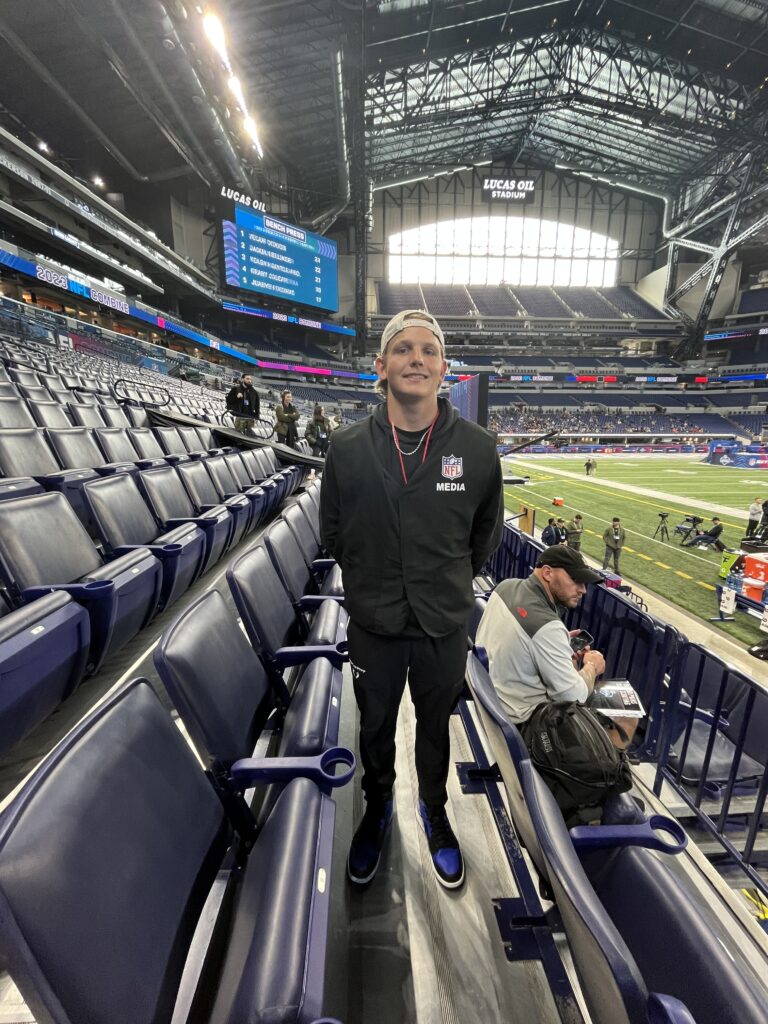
[366,27,751,190]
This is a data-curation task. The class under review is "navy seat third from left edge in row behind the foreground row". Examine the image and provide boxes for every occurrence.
[83,473,206,608]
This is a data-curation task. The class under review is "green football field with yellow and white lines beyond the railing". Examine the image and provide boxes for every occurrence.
[504,455,768,644]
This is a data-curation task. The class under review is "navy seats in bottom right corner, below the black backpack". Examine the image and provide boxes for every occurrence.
[467,634,768,1024]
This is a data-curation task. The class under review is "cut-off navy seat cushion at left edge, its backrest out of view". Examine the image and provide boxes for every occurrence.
[0,591,91,754]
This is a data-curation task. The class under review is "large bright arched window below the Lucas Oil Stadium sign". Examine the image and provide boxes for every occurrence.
[388,215,618,287]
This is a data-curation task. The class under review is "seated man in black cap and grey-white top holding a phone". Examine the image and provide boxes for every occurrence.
[476,546,637,750]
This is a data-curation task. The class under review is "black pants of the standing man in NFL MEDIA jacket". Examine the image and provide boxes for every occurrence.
[347,622,467,806]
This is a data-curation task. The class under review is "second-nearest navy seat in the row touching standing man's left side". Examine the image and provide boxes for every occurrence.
[155,591,348,822]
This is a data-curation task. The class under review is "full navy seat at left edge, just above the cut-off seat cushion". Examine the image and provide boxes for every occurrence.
[0,489,162,672]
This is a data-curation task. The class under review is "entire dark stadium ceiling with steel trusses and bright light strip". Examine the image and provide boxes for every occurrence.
[0,0,768,352]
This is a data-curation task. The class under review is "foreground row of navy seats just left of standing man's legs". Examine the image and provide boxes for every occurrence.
[0,481,355,1024]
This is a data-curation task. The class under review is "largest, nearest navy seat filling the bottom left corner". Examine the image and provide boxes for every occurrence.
[0,680,342,1024]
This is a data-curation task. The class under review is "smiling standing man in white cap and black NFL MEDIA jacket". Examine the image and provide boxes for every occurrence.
[321,309,504,889]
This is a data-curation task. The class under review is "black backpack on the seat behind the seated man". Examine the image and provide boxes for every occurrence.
[521,700,632,824]
